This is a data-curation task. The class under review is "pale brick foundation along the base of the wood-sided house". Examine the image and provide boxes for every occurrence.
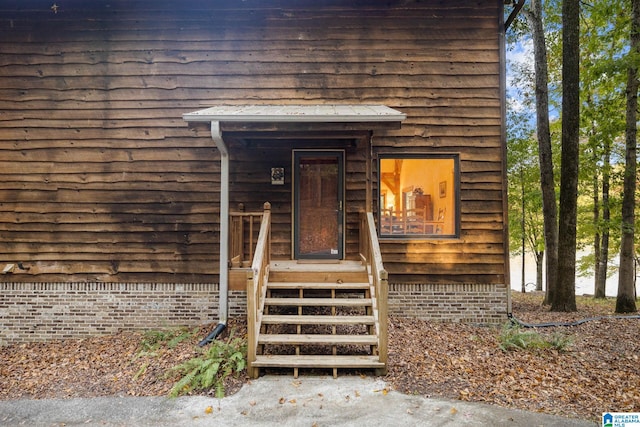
[0,283,507,345]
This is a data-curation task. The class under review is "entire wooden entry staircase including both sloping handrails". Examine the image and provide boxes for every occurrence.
[244,209,389,378]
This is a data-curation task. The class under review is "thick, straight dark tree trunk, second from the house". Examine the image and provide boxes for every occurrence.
[551,0,580,311]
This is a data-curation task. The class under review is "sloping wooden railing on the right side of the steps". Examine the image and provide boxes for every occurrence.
[360,212,389,374]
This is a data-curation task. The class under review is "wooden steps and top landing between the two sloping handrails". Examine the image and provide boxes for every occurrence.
[252,261,386,377]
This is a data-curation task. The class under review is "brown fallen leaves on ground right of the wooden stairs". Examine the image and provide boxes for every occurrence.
[386,293,640,421]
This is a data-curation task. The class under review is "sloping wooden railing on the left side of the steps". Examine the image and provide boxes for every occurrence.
[247,202,271,378]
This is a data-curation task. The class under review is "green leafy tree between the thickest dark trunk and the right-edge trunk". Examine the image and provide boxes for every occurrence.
[578,0,628,298]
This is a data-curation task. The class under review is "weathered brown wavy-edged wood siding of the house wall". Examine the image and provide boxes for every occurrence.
[0,0,506,283]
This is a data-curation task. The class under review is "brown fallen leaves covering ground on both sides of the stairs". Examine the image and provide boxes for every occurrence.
[0,292,640,421]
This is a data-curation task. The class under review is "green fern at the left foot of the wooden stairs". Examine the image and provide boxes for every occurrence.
[169,331,247,398]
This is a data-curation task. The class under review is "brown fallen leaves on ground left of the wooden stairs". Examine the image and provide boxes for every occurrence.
[0,322,246,400]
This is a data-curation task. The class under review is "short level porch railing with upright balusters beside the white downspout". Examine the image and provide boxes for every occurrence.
[229,204,263,268]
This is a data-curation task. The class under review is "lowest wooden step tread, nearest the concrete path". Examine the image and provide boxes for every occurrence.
[251,355,384,369]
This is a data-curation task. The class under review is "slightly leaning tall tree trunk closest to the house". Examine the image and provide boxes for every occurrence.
[524,0,558,304]
